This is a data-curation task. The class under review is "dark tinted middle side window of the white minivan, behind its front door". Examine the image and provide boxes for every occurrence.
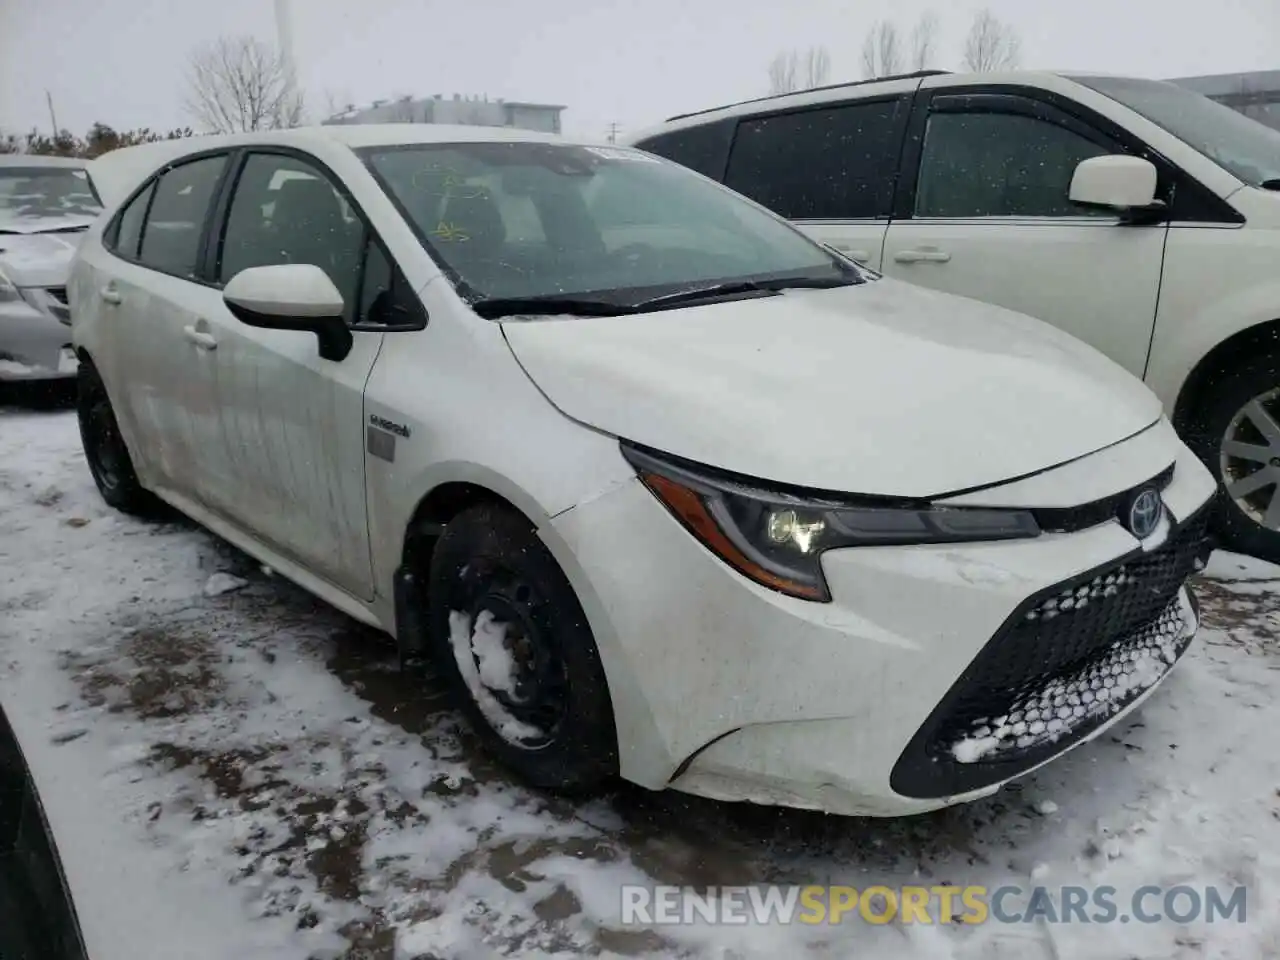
[724,97,906,220]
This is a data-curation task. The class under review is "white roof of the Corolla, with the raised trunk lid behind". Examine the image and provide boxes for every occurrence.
[88,123,619,206]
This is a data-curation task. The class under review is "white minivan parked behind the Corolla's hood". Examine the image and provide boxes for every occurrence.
[628,70,1280,562]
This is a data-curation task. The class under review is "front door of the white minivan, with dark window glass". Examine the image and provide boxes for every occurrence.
[882,86,1167,376]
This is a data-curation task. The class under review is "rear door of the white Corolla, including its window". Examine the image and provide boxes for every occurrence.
[95,152,228,498]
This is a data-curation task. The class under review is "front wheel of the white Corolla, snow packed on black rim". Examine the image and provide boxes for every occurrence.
[428,504,618,794]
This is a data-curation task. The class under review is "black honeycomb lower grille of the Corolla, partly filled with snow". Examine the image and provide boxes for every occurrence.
[890,509,1208,797]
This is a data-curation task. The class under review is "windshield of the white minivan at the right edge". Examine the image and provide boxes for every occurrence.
[1073,77,1280,187]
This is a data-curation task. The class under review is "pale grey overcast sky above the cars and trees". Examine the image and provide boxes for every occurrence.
[0,0,1280,137]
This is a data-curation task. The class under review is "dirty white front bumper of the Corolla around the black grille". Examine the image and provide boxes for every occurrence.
[548,431,1215,815]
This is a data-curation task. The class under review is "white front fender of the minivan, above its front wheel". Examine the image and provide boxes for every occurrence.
[1146,209,1280,413]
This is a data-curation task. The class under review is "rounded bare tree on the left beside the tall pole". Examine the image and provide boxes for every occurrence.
[187,36,303,133]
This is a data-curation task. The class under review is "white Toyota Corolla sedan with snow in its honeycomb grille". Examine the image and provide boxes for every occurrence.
[70,124,1215,815]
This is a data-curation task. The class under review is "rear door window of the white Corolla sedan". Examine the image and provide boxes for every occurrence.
[138,156,227,276]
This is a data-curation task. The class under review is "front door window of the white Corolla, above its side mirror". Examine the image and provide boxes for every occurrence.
[218,154,365,323]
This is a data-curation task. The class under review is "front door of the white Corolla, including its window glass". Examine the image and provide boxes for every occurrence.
[201,152,383,599]
